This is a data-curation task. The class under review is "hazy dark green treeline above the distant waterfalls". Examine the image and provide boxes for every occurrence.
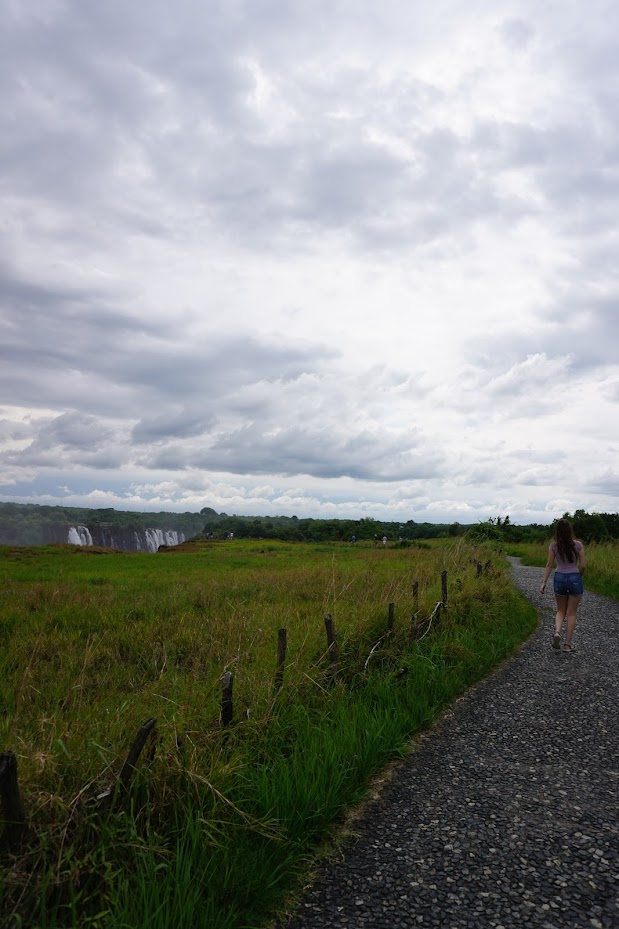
[0,503,204,545]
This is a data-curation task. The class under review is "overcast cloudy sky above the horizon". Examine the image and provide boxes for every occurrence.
[0,0,619,523]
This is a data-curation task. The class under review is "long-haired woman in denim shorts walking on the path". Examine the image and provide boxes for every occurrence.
[540,519,586,652]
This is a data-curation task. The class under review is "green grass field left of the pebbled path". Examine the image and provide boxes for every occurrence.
[0,540,536,929]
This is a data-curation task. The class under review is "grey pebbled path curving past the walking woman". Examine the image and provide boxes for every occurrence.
[286,559,619,929]
